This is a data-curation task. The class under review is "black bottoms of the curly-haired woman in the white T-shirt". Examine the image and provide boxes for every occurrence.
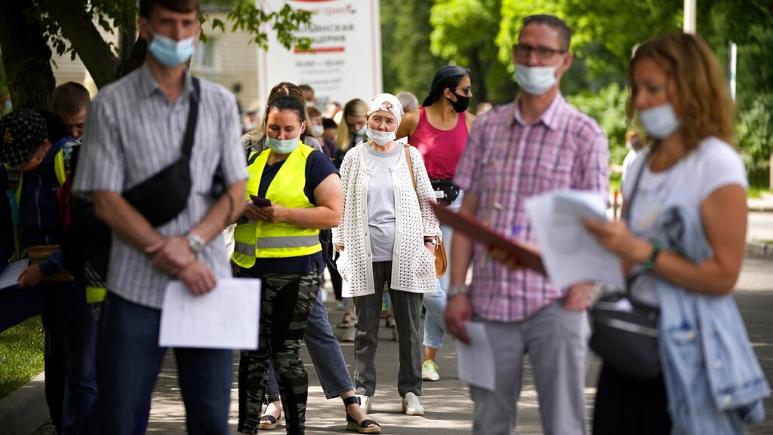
[593,364,671,435]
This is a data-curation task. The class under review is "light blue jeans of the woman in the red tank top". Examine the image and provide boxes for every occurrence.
[423,192,464,349]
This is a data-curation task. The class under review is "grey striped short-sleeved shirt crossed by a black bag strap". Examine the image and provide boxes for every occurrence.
[73,64,247,308]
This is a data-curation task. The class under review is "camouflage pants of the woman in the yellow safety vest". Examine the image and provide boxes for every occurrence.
[238,271,322,434]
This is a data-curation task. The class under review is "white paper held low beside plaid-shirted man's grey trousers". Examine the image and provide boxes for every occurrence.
[456,322,496,391]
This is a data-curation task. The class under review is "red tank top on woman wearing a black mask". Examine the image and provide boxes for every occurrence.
[408,107,469,180]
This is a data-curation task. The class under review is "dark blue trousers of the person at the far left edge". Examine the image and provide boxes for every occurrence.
[0,281,97,434]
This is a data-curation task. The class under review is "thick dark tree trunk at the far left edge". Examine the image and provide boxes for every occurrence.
[0,0,56,108]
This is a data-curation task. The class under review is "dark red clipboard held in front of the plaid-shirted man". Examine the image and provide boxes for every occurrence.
[432,204,547,276]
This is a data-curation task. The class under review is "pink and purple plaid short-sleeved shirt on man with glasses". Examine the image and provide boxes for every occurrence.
[455,94,609,322]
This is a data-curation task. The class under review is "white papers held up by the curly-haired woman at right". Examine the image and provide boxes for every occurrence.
[526,190,624,288]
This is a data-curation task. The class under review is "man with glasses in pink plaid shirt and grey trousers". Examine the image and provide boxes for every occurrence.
[446,15,608,434]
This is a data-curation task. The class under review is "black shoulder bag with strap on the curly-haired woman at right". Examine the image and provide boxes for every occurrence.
[589,155,661,380]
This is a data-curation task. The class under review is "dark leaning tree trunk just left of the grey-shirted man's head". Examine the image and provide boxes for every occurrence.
[46,0,118,88]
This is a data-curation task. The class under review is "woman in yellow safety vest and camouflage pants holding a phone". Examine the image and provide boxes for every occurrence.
[232,96,343,434]
